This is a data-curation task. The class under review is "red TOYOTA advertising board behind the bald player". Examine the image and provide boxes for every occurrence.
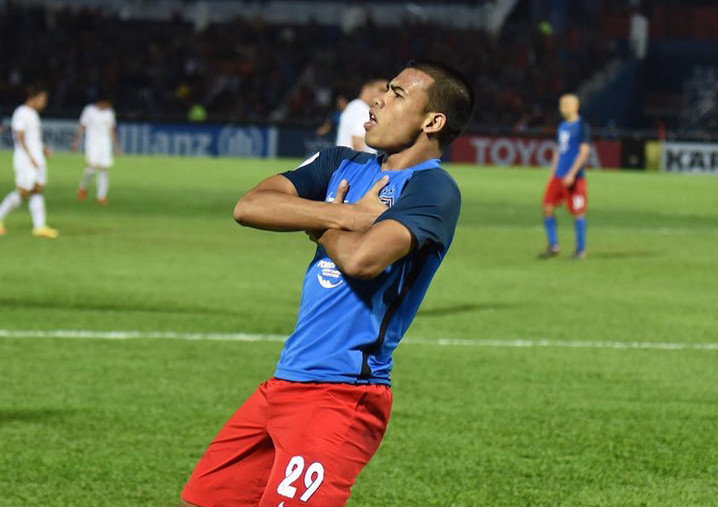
[451,135,621,169]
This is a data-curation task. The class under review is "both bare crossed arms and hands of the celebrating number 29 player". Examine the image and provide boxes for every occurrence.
[234,175,415,279]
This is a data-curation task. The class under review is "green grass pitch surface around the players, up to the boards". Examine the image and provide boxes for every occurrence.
[0,153,718,507]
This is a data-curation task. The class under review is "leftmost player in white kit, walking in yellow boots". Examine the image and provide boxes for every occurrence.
[0,86,58,239]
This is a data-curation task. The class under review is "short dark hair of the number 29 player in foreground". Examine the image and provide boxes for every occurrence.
[404,60,474,149]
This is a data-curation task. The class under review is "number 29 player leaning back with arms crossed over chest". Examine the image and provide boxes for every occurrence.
[180,61,473,507]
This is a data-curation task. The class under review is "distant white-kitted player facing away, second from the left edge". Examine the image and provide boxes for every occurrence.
[72,98,120,205]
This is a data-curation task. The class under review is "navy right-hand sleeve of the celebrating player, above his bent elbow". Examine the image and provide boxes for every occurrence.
[376,170,461,248]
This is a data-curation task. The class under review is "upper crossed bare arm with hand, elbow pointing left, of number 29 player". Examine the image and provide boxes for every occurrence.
[234,175,387,232]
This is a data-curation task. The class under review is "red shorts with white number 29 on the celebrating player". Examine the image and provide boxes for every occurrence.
[182,378,392,507]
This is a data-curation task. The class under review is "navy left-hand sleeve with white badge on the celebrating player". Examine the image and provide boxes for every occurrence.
[282,147,352,201]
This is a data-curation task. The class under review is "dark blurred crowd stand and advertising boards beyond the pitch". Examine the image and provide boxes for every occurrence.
[0,0,718,170]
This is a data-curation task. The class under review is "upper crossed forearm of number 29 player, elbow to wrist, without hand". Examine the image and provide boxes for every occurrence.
[234,190,351,232]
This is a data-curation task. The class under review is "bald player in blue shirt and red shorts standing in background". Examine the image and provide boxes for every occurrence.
[541,94,591,259]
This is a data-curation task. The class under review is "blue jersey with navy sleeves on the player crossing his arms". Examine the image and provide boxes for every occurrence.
[275,147,461,384]
